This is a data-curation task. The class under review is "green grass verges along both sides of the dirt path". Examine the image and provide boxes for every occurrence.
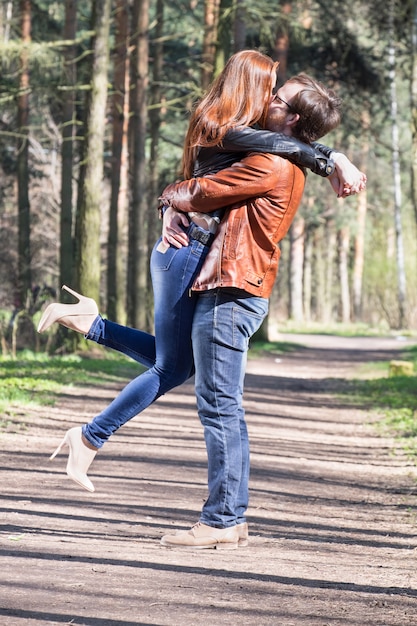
[0,342,417,460]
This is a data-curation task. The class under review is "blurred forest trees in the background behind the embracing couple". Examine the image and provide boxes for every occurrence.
[0,0,417,350]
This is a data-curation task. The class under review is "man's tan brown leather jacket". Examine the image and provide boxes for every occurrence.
[161,154,305,298]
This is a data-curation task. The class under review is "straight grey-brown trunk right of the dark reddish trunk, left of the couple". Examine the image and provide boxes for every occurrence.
[127,0,149,329]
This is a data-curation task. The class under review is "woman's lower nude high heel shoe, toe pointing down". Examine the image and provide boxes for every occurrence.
[49,426,97,491]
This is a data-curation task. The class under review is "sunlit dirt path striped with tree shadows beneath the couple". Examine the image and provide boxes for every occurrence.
[0,336,417,626]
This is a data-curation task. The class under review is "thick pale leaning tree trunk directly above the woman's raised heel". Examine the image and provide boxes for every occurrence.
[76,0,111,302]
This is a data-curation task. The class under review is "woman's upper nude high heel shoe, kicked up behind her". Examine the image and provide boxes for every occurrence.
[38,285,98,335]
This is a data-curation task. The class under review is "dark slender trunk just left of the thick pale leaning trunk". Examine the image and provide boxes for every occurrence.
[59,0,77,292]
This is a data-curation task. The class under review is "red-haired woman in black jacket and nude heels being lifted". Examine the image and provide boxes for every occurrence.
[38,51,361,491]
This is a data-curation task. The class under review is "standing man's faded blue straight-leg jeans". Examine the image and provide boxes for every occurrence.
[192,288,268,528]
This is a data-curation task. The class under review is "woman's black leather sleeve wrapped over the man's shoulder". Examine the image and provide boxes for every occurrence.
[222,128,334,177]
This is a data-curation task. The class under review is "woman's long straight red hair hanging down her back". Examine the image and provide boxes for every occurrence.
[182,50,278,178]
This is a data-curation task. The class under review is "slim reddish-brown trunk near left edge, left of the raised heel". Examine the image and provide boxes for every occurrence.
[16,0,31,309]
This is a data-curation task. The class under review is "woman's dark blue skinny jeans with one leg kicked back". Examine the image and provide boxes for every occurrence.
[83,232,209,448]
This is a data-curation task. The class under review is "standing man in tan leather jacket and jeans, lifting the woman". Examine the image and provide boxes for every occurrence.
[161,75,364,549]
